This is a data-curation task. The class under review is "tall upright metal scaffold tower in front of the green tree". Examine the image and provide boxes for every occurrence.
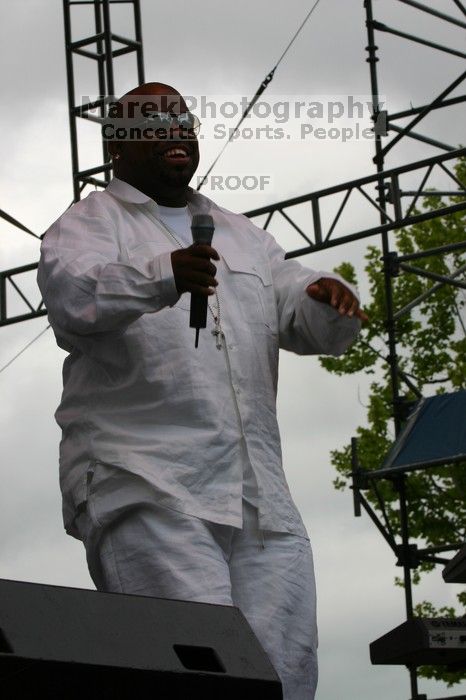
[353,0,466,700]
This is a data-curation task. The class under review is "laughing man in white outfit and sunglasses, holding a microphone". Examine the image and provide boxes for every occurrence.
[38,83,366,700]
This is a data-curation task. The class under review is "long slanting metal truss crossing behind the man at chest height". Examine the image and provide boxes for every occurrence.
[0,148,466,326]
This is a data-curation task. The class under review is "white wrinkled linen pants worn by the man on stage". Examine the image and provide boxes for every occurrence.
[74,464,317,700]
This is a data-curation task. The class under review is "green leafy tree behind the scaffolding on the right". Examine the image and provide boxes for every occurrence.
[320,159,466,685]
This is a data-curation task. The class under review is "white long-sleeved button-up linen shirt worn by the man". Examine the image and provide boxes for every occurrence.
[38,178,360,536]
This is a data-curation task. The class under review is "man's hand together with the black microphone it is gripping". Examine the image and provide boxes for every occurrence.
[171,214,220,347]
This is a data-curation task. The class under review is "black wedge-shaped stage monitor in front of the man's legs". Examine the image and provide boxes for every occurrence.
[0,579,283,700]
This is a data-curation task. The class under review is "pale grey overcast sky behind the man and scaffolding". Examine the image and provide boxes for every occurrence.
[0,0,465,700]
